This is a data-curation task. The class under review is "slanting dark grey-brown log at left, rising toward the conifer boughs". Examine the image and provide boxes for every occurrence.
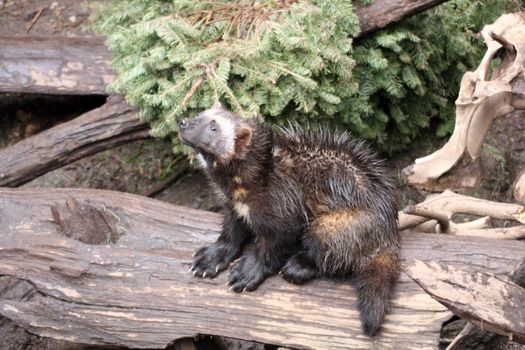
[0,96,148,186]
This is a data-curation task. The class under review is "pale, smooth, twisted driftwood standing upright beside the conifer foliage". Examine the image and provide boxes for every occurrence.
[403,12,525,191]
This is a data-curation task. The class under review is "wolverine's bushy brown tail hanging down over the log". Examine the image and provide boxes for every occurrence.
[356,250,399,336]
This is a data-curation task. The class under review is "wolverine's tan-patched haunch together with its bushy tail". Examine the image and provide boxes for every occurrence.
[298,208,399,336]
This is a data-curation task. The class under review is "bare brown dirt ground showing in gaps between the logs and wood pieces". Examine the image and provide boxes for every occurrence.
[0,0,525,350]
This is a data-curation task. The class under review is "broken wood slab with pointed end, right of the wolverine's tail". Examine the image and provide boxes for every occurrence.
[405,260,525,344]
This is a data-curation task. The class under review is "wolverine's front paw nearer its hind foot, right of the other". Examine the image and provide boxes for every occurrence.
[228,255,266,292]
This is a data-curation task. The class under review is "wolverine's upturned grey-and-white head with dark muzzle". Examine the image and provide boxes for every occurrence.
[179,103,252,164]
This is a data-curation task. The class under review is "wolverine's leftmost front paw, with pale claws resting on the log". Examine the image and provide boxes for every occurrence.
[190,243,235,278]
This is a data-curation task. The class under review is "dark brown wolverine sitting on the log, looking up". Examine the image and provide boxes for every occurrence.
[179,103,399,336]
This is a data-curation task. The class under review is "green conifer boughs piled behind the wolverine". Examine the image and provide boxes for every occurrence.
[95,0,517,153]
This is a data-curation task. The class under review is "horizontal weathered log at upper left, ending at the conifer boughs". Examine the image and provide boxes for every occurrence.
[0,36,114,95]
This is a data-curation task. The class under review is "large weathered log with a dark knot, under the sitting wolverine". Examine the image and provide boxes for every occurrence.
[0,188,525,349]
